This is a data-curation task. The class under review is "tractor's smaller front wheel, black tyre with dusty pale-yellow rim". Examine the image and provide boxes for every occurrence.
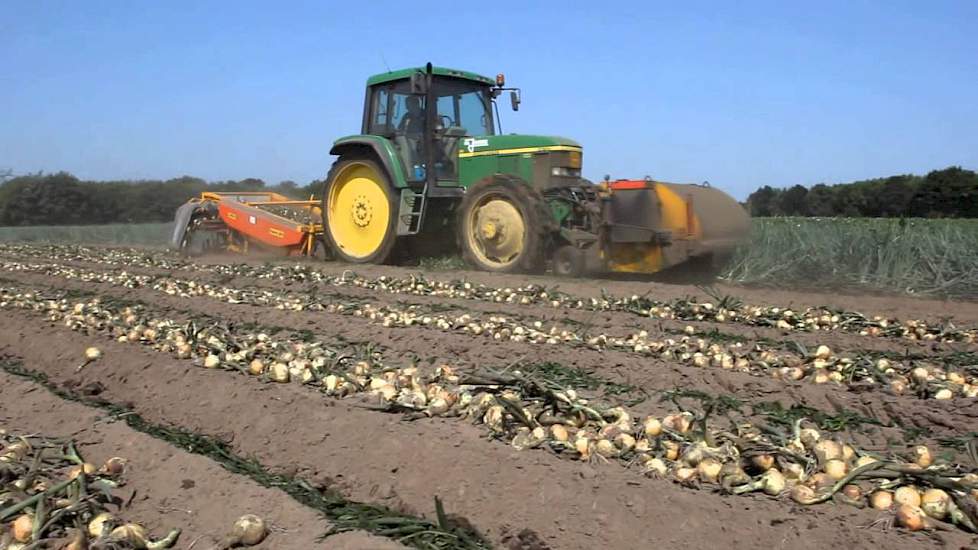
[456,174,552,272]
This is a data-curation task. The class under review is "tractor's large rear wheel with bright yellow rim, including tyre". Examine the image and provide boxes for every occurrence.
[323,157,397,263]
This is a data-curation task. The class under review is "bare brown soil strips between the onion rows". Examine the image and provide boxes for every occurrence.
[0,247,978,549]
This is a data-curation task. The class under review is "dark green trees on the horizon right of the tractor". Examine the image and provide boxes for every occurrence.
[746,166,978,218]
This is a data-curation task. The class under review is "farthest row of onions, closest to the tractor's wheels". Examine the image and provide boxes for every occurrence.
[0,244,978,344]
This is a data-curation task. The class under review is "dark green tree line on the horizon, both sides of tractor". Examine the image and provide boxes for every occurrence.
[0,166,978,226]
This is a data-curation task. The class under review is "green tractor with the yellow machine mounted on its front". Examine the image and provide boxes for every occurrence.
[322,63,748,275]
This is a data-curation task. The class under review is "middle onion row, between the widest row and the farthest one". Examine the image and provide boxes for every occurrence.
[3,262,978,400]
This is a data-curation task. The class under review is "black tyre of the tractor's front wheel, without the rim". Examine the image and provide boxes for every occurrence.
[455,174,554,273]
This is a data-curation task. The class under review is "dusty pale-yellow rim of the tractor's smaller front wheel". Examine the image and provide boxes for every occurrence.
[465,195,526,268]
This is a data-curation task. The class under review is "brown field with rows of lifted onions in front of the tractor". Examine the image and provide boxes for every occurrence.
[0,243,978,550]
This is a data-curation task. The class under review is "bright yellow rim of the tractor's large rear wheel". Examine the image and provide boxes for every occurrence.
[326,163,390,258]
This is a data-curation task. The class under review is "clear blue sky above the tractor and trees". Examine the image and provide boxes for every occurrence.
[0,0,978,198]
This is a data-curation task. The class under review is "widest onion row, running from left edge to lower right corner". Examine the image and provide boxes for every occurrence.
[0,288,978,532]
